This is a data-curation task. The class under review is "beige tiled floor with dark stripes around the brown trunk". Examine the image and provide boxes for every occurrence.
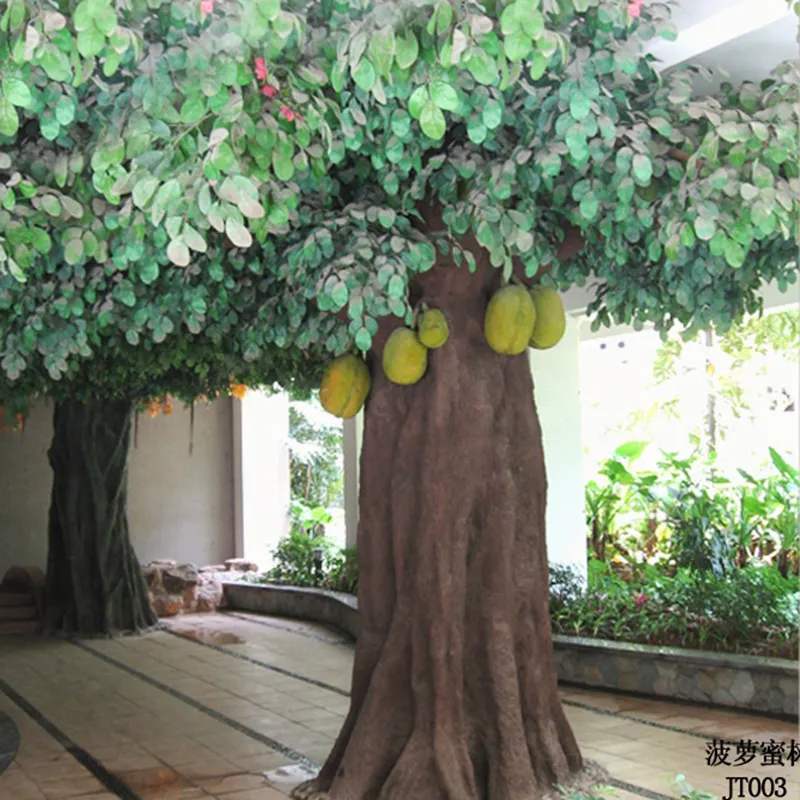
[0,614,800,800]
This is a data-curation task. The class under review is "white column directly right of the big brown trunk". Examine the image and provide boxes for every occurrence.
[529,315,587,576]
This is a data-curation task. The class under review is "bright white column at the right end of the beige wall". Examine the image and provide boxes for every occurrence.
[233,391,291,569]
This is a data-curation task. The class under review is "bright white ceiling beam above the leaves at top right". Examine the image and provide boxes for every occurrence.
[648,0,797,70]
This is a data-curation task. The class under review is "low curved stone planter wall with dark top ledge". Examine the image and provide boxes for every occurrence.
[223,582,800,720]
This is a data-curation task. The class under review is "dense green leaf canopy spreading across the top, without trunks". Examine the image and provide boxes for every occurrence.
[0,0,800,412]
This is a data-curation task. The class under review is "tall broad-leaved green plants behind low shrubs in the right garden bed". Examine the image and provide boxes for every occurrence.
[586,441,800,577]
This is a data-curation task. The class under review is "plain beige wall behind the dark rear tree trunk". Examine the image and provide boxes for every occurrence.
[0,398,234,575]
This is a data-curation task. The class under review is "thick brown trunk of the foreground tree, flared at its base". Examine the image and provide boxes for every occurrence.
[294,248,582,800]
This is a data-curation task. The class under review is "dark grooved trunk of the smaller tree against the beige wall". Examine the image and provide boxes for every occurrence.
[46,400,156,636]
